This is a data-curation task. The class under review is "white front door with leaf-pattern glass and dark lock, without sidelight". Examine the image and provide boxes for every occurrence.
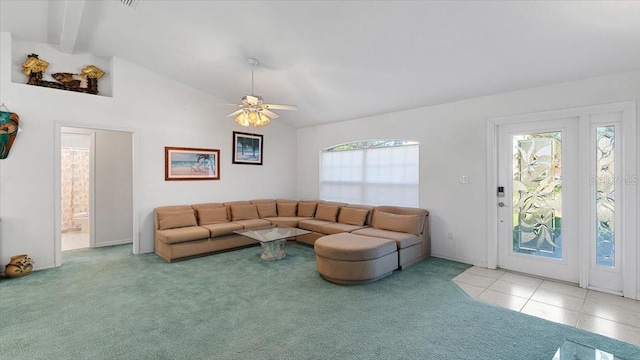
[497,117,580,283]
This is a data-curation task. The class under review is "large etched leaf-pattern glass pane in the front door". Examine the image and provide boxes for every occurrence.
[513,131,562,259]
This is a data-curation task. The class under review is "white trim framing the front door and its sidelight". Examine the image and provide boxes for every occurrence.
[486,101,640,299]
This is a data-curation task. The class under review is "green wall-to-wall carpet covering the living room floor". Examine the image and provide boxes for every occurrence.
[0,244,640,360]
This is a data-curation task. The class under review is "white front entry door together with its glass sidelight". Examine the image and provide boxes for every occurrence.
[496,107,637,296]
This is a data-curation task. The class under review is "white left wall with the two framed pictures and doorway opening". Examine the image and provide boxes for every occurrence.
[0,33,296,269]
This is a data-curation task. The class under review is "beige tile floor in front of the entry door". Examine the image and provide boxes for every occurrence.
[453,266,640,346]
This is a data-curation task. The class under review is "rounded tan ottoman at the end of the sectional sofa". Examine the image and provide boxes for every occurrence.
[313,233,398,284]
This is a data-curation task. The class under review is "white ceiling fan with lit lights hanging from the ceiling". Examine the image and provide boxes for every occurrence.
[227,58,298,127]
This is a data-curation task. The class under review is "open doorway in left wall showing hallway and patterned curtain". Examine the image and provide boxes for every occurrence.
[56,126,136,258]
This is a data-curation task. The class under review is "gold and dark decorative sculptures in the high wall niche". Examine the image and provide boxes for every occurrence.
[22,54,104,94]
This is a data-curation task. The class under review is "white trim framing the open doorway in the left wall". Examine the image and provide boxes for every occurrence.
[53,121,140,267]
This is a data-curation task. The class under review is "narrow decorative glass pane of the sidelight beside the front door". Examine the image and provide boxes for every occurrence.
[595,125,616,268]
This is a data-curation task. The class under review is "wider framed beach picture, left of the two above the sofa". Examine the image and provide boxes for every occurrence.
[164,146,220,181]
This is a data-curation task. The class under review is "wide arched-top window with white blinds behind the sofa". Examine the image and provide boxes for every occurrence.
[320,140,420,207]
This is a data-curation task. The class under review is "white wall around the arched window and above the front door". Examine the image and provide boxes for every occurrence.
[297,71,640,272]
